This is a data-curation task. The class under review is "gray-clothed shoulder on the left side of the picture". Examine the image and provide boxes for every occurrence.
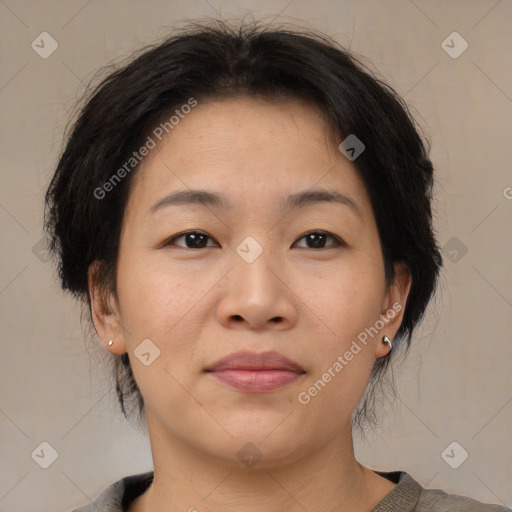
[71,471,153,512]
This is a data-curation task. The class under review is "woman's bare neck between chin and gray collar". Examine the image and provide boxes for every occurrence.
[129,415,394,512]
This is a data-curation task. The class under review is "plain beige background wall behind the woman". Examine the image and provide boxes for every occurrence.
[0,0,512,512]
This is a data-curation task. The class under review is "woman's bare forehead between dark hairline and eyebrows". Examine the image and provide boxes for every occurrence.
[125,97,368,217]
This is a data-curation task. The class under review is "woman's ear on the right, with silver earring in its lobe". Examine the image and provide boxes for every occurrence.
[375,262,412,357]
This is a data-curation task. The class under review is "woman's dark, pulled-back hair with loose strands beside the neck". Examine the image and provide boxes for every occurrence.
[45,20,442,427]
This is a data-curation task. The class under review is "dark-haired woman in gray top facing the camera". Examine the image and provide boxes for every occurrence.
[47,18,506,512]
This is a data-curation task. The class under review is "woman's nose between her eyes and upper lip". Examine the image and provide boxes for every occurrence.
[217,245,299,331]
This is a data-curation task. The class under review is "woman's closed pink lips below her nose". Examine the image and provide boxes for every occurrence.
[206,351,306,393]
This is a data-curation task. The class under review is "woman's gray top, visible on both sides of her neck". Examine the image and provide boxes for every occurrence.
[71,471,512,512]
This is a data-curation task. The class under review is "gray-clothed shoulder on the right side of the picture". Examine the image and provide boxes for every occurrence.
[372,471,512,512]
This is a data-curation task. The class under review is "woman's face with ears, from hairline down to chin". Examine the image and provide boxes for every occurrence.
[91,98,409,466]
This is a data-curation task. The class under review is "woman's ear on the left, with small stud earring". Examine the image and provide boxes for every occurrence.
[87,260,127,355]
